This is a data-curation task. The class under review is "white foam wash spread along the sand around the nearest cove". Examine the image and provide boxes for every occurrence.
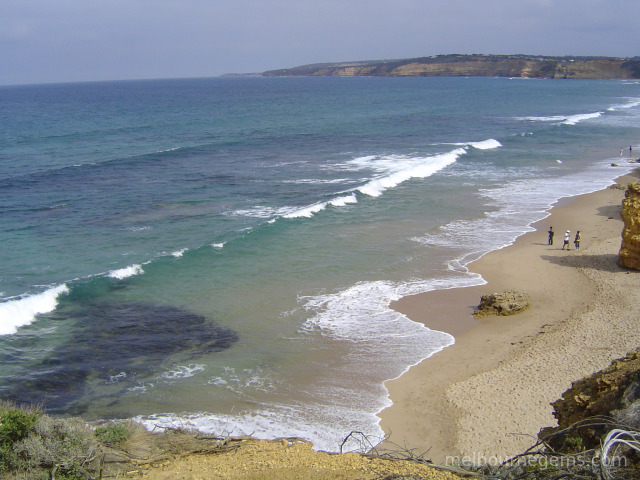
[135,274,482,452]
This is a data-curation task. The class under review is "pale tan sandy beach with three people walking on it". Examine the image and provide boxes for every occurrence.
[380,167,640,463]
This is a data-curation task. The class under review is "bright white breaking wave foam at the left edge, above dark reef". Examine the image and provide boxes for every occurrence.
[0,285,69,335]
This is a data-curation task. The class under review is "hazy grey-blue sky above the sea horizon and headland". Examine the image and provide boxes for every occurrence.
[0,0,640,85]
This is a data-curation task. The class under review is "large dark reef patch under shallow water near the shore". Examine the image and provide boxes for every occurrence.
[0,302,238,415]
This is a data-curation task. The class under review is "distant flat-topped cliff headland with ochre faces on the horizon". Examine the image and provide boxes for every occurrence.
[262,55,640,79]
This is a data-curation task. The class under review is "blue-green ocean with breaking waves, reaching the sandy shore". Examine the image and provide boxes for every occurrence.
[0,77,640,451]
